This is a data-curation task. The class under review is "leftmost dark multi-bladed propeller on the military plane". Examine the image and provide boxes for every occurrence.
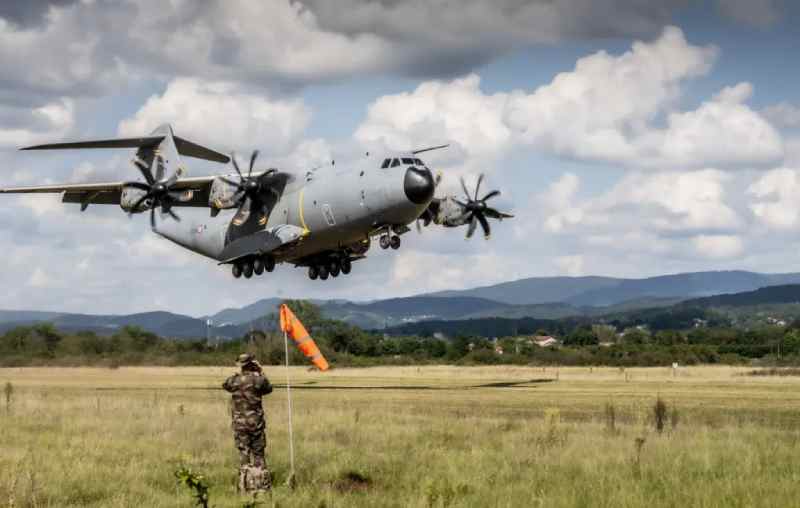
[122,153,194,229]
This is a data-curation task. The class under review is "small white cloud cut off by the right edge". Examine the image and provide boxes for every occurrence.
[747,168,800,229]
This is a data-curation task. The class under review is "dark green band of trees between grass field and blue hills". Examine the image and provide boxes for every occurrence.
[0,301,800,368]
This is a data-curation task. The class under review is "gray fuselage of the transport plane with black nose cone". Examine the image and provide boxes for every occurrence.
[157,157,433,264]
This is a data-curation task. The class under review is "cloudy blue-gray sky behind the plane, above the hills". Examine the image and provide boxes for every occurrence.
[0,0,800,315]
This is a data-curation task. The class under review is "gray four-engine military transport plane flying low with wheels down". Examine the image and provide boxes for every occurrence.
[0,125,513,280]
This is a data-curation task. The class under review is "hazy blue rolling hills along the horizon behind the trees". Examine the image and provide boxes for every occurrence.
[0,271,800,338]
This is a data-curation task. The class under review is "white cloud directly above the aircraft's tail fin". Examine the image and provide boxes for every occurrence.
[119,78,311,154]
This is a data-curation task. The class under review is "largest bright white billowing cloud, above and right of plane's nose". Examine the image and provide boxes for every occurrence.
[356,27,783,170]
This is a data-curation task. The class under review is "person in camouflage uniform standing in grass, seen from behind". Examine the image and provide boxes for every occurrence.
[222,353,272,491]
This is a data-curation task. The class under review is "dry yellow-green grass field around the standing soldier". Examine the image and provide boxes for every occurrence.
[0,367,800,507]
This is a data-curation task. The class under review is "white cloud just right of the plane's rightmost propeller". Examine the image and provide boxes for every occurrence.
[541,169,745,258]
